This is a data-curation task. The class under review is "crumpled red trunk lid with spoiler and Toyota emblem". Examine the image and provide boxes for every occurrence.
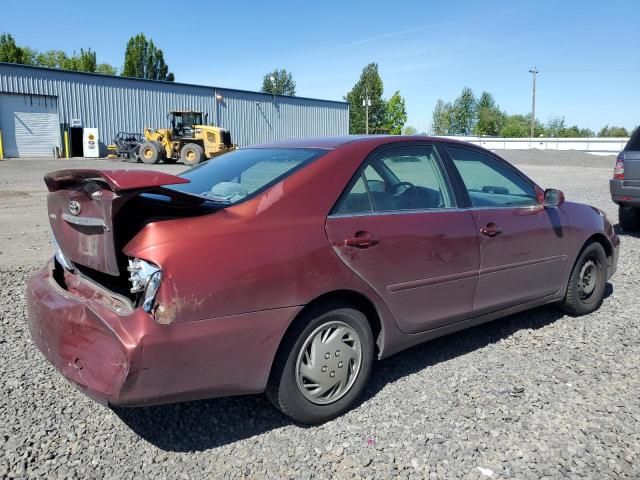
[44,169,189,275]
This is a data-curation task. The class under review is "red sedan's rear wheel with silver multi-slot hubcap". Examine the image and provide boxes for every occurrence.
[266,302,374,424]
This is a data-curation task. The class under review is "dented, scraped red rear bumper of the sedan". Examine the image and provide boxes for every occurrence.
[27,262,301,405]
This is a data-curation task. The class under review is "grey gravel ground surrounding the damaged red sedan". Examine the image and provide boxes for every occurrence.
[0,151,640,479]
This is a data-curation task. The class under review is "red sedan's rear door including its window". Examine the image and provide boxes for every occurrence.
[326,145,480,333]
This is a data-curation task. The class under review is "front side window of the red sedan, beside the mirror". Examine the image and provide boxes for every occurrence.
[446,147,538,207]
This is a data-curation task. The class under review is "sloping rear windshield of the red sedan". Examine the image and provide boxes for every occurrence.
[169,148,326,203]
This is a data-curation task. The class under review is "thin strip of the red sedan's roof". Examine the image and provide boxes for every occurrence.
[248,135,472,150]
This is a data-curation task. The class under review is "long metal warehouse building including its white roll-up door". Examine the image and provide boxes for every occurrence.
[0,63,349,157]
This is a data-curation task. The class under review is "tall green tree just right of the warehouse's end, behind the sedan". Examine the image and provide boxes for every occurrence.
[344,63,387,134]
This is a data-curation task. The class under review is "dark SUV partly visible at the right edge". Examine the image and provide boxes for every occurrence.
[609,127,640,232]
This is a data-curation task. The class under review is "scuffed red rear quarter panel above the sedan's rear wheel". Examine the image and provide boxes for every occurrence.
[124,143,395,334]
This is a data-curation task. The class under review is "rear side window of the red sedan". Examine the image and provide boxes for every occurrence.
[335,146,455,214]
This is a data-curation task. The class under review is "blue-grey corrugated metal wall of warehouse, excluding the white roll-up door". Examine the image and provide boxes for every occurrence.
[0,63,349,154]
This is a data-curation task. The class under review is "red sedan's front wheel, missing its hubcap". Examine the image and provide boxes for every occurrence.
[560,242,607,317]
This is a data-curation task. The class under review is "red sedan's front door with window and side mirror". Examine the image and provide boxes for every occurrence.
[445,146,567,315]
